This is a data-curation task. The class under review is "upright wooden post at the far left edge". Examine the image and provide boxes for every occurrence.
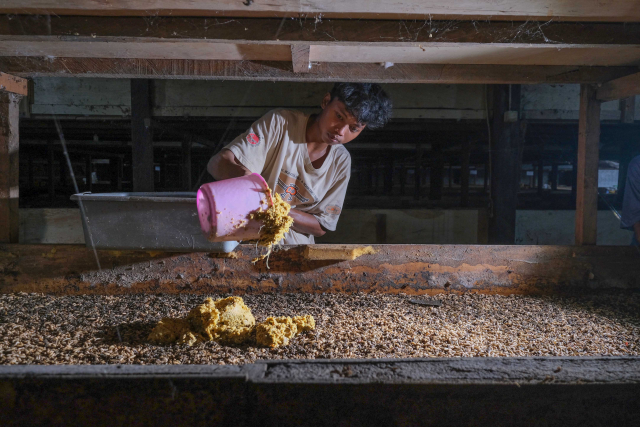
[0,92,20,243]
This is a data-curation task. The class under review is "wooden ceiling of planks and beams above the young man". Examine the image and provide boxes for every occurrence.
[0,0,640,83]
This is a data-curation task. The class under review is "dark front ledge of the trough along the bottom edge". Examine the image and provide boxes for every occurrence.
[0,357,640,427]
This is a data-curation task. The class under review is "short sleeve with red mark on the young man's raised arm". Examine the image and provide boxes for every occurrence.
[225,110,284,173]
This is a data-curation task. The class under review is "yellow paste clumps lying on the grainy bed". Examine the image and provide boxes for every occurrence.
[149,297,316,347]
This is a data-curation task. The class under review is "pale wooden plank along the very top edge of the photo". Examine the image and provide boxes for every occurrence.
[0,0,640,22]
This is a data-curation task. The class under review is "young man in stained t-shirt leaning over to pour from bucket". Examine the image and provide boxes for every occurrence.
[207,83,391,245]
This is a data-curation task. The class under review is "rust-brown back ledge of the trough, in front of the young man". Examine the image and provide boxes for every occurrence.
[0,245,640,295]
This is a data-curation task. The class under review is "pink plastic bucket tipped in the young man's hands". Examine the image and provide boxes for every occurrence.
[197,173,270,242]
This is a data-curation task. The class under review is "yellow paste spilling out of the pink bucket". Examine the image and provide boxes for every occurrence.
[249,189,293,262]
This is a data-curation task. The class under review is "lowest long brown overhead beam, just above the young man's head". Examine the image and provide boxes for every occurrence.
[0,57,638,84]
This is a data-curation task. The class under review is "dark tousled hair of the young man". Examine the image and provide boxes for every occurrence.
[331,83,391,129]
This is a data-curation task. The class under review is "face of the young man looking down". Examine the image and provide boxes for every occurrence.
[317,94,366,145]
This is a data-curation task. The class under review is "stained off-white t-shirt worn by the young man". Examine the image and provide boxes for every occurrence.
[225,110,351,245]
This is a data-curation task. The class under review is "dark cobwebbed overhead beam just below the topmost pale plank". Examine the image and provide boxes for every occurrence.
[0,15,640,46]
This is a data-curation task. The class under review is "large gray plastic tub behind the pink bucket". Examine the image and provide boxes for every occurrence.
[71,192,238,252]
